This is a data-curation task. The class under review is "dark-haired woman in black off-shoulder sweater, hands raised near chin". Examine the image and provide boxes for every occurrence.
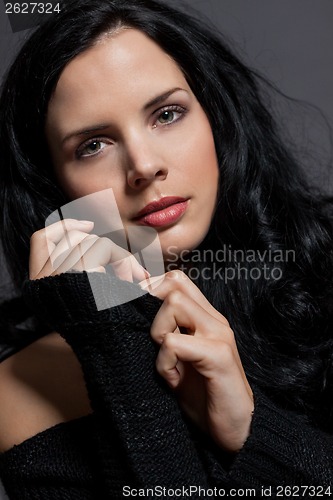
[0,0,333,499]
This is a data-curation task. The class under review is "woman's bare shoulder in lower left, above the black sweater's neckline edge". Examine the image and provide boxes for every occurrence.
[0,333,91,452]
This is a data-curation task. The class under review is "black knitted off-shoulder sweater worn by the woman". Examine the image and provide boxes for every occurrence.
[0,273,333,500]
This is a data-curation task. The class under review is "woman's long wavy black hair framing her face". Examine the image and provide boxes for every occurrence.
[0,0,333,427]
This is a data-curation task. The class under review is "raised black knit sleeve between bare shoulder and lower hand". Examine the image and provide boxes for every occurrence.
[23,273,207,498]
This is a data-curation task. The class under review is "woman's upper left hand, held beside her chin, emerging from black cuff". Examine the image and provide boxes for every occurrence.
[29,219,148,281]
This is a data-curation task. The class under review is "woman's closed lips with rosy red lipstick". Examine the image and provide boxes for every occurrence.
[133,196,188,227]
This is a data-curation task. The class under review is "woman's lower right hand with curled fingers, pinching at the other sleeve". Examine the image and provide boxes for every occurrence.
[141,271,254,452]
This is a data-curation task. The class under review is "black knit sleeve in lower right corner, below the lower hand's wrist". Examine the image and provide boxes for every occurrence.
[202,387,333,498]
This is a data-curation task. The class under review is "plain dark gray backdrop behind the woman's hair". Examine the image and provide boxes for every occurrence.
[0,0,333,498]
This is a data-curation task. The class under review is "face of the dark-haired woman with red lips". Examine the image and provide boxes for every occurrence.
[46,29,218,259]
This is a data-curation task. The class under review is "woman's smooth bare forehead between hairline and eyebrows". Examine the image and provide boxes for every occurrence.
[48,29,189,125]
